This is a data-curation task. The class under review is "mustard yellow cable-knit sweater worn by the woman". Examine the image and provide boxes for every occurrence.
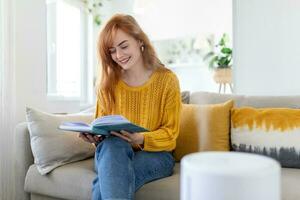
[95,69,181,151]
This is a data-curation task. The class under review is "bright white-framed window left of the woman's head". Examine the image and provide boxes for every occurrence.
[47,0,93,103]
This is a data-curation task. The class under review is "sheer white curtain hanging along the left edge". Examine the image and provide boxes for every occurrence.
[0,0,15,200]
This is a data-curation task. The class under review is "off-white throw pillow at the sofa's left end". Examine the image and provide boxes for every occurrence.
[26,108,95,175]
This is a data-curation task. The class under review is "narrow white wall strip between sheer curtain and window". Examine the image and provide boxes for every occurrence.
[15,0,46,120]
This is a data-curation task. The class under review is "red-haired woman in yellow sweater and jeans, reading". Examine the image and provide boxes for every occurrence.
[80,14,181,200]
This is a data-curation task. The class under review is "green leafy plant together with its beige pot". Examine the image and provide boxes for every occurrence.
[203,33,232,86]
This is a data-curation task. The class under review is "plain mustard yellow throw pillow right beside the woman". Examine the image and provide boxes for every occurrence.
[174,100,233,161]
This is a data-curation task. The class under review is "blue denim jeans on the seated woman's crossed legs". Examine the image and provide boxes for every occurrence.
[92,136,175,200]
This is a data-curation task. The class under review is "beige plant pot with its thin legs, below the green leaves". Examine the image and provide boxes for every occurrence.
[213,68,233,93]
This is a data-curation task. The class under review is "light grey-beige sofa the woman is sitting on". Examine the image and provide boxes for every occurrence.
[14,92,300,200]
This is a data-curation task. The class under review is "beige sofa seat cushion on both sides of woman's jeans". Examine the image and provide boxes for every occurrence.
[25,159,179,200]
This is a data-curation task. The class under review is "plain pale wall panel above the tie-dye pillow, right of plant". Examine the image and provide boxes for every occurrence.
[233,0,300,95]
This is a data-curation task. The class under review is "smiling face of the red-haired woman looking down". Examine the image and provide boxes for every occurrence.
[109,29,143,70]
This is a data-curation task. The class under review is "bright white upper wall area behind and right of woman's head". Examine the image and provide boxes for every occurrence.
[134,0,232,40]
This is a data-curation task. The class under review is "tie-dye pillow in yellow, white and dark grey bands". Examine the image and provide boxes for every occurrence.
[231,107,300,168]
